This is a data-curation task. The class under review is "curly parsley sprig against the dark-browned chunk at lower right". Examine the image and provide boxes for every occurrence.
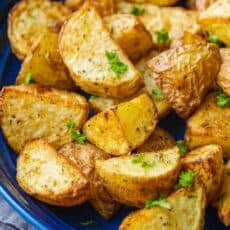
[174,170,197,189]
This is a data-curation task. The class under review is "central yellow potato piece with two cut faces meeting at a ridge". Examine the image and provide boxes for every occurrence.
[83,94,157,155]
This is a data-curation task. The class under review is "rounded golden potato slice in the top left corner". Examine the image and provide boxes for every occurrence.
[8,0,71,60]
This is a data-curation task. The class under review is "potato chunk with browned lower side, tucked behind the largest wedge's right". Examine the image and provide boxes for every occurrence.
[104,14,153,61]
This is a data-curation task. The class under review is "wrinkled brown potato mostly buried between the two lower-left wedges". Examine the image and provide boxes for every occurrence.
[58,143,121,219]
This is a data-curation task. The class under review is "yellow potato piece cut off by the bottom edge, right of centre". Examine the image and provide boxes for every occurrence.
[119,188,206,230]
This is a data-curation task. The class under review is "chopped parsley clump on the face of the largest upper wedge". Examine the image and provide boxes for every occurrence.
[105,51,128,78]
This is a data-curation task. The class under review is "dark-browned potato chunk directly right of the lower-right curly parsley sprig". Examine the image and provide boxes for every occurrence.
[182,145,224,203]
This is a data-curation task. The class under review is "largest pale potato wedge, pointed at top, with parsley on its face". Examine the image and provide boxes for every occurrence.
[59,3,143,98]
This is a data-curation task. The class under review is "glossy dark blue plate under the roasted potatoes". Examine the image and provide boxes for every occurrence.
[0,0,230,230]
